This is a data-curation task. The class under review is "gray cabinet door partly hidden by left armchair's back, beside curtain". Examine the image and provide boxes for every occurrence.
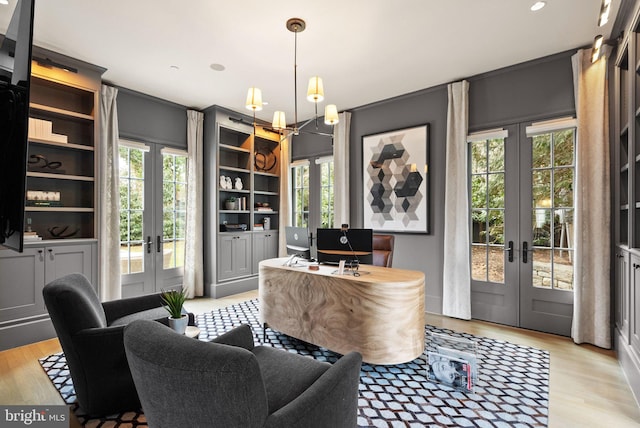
[44,244,93,292]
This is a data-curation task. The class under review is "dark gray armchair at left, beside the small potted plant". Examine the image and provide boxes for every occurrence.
[43,274,188,415]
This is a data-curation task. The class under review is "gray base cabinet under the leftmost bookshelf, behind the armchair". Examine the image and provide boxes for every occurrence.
[0,241,97,350]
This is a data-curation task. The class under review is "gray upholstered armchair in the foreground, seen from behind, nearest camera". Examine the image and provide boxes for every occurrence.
[124,321,362,428]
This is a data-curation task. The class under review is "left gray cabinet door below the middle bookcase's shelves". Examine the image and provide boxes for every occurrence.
[217,232,252,281]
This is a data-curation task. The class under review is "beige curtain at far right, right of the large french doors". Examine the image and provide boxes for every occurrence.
[571,46,611,348]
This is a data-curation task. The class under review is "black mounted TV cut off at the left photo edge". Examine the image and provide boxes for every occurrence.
[0,0,35,252]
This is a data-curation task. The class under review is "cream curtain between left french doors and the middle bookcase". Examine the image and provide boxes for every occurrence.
[182,110,204,298]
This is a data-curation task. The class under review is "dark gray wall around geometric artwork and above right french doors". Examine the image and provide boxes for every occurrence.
[342,51,575,313]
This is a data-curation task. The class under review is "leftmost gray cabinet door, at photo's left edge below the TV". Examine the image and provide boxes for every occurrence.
[0,248,46,324]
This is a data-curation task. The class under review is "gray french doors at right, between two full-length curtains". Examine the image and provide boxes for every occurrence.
[469,121,575,336]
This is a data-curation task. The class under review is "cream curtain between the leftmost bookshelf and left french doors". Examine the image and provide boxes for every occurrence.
[98,85,122,301]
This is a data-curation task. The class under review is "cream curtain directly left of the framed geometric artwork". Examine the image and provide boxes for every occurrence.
[333,111,351,227]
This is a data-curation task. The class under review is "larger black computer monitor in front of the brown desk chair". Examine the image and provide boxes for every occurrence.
[316,227,373,266]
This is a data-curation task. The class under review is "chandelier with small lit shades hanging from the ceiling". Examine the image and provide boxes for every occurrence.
[245,18,339,135]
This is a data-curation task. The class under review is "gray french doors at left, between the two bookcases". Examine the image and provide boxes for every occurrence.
[119,140,187,297]
